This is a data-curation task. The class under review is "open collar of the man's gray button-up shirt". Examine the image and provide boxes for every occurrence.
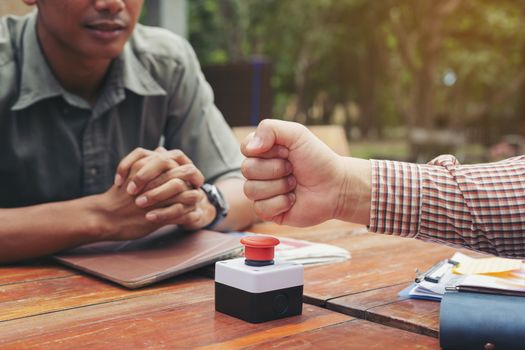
[11,11,166,111]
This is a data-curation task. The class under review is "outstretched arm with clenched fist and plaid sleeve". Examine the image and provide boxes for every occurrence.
[242,120,525,258]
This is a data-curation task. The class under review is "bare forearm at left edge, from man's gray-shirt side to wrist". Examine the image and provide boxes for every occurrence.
[0,196,101,263]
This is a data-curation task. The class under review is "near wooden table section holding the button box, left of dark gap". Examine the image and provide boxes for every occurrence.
[0,261,438,349]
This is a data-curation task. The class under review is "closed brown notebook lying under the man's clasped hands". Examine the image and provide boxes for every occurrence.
[54,226,241,288]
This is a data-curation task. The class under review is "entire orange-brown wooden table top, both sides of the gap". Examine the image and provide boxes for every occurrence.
[0,221,454,349]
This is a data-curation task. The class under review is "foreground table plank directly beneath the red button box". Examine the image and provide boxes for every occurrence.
[0,279,352,349]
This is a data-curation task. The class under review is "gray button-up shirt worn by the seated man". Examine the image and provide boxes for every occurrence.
[0,13,242,208]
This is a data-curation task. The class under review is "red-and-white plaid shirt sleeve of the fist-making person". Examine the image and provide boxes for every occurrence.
[369,155,525,258]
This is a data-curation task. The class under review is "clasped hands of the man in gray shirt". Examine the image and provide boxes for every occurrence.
[107,147,216,239]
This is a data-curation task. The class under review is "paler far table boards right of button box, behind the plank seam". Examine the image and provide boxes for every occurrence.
[253,220,457,306]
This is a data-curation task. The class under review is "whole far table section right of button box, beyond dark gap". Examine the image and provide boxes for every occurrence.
[251,220,480,338]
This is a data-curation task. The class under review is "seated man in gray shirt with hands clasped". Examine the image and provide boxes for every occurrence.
[0,0,254,262]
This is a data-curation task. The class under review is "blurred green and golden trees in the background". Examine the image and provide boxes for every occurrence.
[188,0,525,159]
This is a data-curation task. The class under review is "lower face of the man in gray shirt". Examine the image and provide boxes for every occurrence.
[33,0,144,59]
